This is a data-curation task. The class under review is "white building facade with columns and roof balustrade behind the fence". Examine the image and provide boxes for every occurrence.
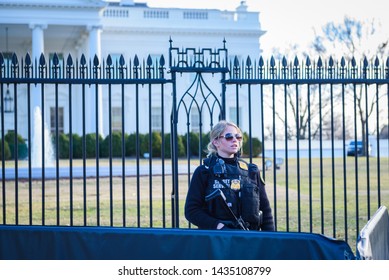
[0,0,265,138]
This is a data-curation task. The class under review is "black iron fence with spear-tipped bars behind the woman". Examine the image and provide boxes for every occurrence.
[0,41,389,247]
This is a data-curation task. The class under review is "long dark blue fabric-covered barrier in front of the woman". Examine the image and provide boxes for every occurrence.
[0,226,355,260]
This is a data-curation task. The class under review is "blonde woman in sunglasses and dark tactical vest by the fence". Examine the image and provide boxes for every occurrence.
[185,121,274,231]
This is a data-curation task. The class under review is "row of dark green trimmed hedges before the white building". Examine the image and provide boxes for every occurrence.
[0,131,262,160]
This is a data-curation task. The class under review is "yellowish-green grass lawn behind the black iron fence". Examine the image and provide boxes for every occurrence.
[0,157,389,252]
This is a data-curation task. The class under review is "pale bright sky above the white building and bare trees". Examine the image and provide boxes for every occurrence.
[144,0,389,55]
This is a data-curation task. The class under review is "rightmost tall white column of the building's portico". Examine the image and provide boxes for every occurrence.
[85,26,104,136]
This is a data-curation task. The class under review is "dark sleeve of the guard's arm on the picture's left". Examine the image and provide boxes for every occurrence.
[185,165,219,229]
